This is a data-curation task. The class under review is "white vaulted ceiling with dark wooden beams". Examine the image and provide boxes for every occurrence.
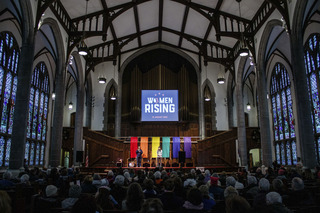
[37,0,288,75]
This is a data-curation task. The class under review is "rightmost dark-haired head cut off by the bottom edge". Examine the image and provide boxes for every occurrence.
[226,195,250,213]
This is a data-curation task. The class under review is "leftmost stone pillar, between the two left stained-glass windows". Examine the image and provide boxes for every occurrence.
[9,40,34,170]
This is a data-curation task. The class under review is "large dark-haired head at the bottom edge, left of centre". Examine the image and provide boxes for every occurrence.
[71,194,98,213]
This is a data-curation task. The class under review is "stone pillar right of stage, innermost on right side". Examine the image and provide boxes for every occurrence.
[236,76,248,167]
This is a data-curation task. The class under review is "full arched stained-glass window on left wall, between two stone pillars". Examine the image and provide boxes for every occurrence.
[25,62,49,165]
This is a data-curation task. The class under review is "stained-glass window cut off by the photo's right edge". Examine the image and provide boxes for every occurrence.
[305,34,320,162]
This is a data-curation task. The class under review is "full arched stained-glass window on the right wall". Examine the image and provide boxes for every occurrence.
[270,63,297,165]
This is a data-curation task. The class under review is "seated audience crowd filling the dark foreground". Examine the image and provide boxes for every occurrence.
[0,162,320,213]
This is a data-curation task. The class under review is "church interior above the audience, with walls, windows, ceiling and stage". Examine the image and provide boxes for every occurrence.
[0,0,320,177]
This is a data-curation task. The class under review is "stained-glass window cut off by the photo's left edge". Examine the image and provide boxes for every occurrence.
[0,32,20,167]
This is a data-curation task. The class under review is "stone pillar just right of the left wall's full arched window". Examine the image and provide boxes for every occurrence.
[49,64,65,167]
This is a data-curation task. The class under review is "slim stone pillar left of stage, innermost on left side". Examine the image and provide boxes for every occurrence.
[73,82,84,165]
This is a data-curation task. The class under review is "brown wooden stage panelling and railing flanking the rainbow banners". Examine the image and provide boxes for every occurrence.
[77,128,260,167]
